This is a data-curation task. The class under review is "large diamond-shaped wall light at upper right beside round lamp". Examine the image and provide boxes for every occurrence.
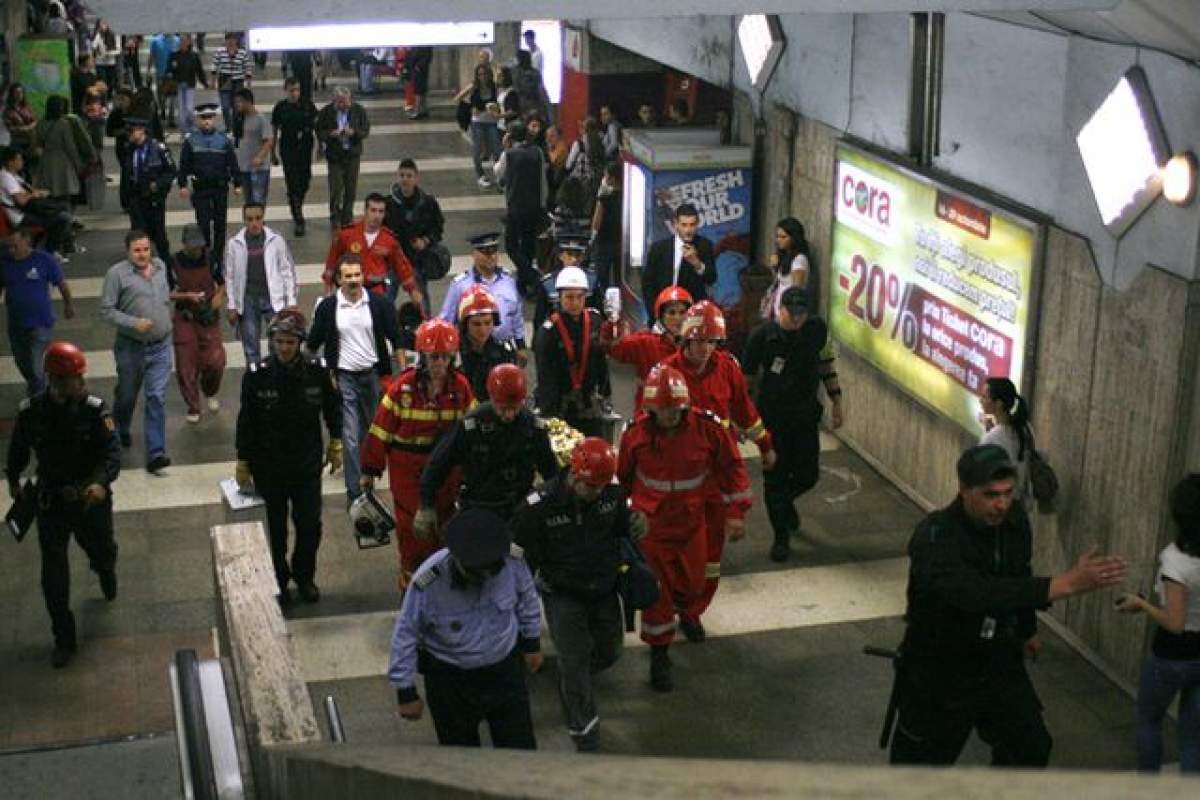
[1075,66,1170,236]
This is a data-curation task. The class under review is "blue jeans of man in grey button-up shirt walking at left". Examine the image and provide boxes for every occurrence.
[113,336,173,463]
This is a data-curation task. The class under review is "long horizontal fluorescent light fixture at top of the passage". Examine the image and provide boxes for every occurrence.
[247,22,496,52]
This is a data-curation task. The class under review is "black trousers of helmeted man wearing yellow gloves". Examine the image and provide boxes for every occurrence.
[253,469,320,589]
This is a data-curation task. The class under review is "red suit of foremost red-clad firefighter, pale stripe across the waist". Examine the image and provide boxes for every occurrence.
[617,413,750,645]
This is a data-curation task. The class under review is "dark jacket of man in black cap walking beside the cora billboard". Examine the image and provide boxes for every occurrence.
[742,317,829,431]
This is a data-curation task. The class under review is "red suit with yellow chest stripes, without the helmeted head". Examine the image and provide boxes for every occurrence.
[360,368,475,590]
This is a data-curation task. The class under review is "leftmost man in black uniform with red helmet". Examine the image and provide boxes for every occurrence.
[7,342,121,668]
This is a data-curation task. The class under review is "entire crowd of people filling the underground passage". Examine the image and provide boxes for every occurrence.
[0,20,1200,769]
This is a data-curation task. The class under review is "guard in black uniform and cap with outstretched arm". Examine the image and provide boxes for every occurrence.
[892,445,1129,766]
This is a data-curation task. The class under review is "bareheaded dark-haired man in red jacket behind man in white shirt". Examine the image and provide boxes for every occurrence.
[320,193,426,309]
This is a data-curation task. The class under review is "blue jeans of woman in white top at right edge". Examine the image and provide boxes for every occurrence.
[1138,654,1200,772]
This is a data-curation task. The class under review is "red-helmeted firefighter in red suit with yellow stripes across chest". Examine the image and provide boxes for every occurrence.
[361,319,475,591]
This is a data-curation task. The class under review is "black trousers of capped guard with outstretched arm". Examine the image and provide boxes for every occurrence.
[890,650,1054,766]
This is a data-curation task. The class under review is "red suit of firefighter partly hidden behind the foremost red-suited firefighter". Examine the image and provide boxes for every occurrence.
[662,350,772,620]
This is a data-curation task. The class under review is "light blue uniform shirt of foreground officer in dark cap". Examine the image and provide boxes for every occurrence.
[388,548,541,688]
